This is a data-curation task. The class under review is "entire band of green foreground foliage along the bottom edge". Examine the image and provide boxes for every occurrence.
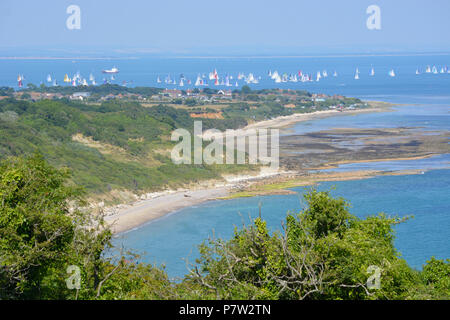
[0,155,450,299]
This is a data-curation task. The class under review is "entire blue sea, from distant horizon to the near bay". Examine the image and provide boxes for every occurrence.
[0,54,450,278]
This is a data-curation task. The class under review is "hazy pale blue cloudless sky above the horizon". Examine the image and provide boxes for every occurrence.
[0,0,450,56]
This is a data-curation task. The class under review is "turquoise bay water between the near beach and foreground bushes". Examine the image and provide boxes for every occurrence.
[115,170,450,277]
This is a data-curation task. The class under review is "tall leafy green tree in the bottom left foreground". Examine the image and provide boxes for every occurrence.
[0,154,111,299]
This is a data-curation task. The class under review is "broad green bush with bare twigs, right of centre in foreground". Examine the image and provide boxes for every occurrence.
[189,190,420,299]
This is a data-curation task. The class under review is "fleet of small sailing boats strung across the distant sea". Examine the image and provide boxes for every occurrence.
[17,65,450,88]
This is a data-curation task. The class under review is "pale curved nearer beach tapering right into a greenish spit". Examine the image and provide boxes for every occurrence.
[105,157,448,235]
